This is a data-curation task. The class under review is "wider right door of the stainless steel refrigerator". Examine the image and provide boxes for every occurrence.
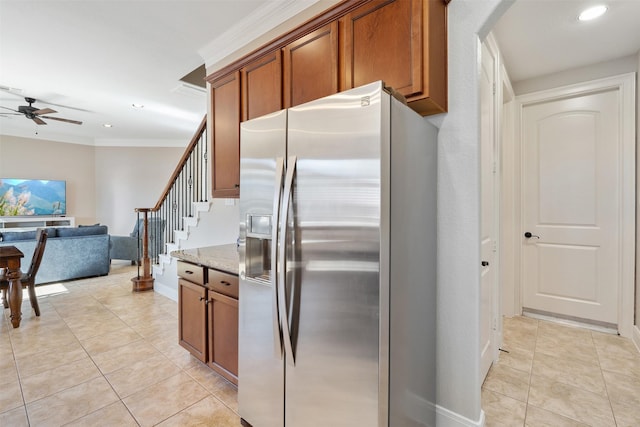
[284,82,388,427]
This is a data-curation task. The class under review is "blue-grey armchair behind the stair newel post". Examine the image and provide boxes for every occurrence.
[109,217,165,264]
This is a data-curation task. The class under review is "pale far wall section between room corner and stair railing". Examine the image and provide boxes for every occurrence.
[94,147,185,235]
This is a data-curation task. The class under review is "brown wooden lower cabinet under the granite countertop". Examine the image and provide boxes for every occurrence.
[178,261,238,385]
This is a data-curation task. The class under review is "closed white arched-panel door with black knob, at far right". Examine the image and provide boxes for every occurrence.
[521,89,622,324]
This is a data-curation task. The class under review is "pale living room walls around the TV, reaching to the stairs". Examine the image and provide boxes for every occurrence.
[0,135,189,235]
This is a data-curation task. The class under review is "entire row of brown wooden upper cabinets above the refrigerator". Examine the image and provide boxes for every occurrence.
[207,0,448,197]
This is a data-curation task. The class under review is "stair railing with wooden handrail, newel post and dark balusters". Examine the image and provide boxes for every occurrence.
[131,115,209,292]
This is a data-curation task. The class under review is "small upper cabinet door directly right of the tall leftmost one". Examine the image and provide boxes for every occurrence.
[241,50,282,121]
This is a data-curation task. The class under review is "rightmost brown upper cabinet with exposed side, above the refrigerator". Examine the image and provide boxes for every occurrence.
[341,0,447,115]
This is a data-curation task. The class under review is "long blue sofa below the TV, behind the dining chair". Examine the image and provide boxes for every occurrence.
[0,225,109,284]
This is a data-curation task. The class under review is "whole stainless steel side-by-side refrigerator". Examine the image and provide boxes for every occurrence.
[238,82,437,427]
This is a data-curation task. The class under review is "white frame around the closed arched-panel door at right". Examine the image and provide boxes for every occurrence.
[514,73,636,338]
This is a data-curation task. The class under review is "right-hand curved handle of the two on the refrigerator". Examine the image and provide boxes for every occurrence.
[278,156,297,366]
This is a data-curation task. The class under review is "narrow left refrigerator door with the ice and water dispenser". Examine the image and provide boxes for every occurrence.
[238,111,287,427]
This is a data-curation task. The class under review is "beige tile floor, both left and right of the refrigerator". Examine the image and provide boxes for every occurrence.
[0,264,640,427]
